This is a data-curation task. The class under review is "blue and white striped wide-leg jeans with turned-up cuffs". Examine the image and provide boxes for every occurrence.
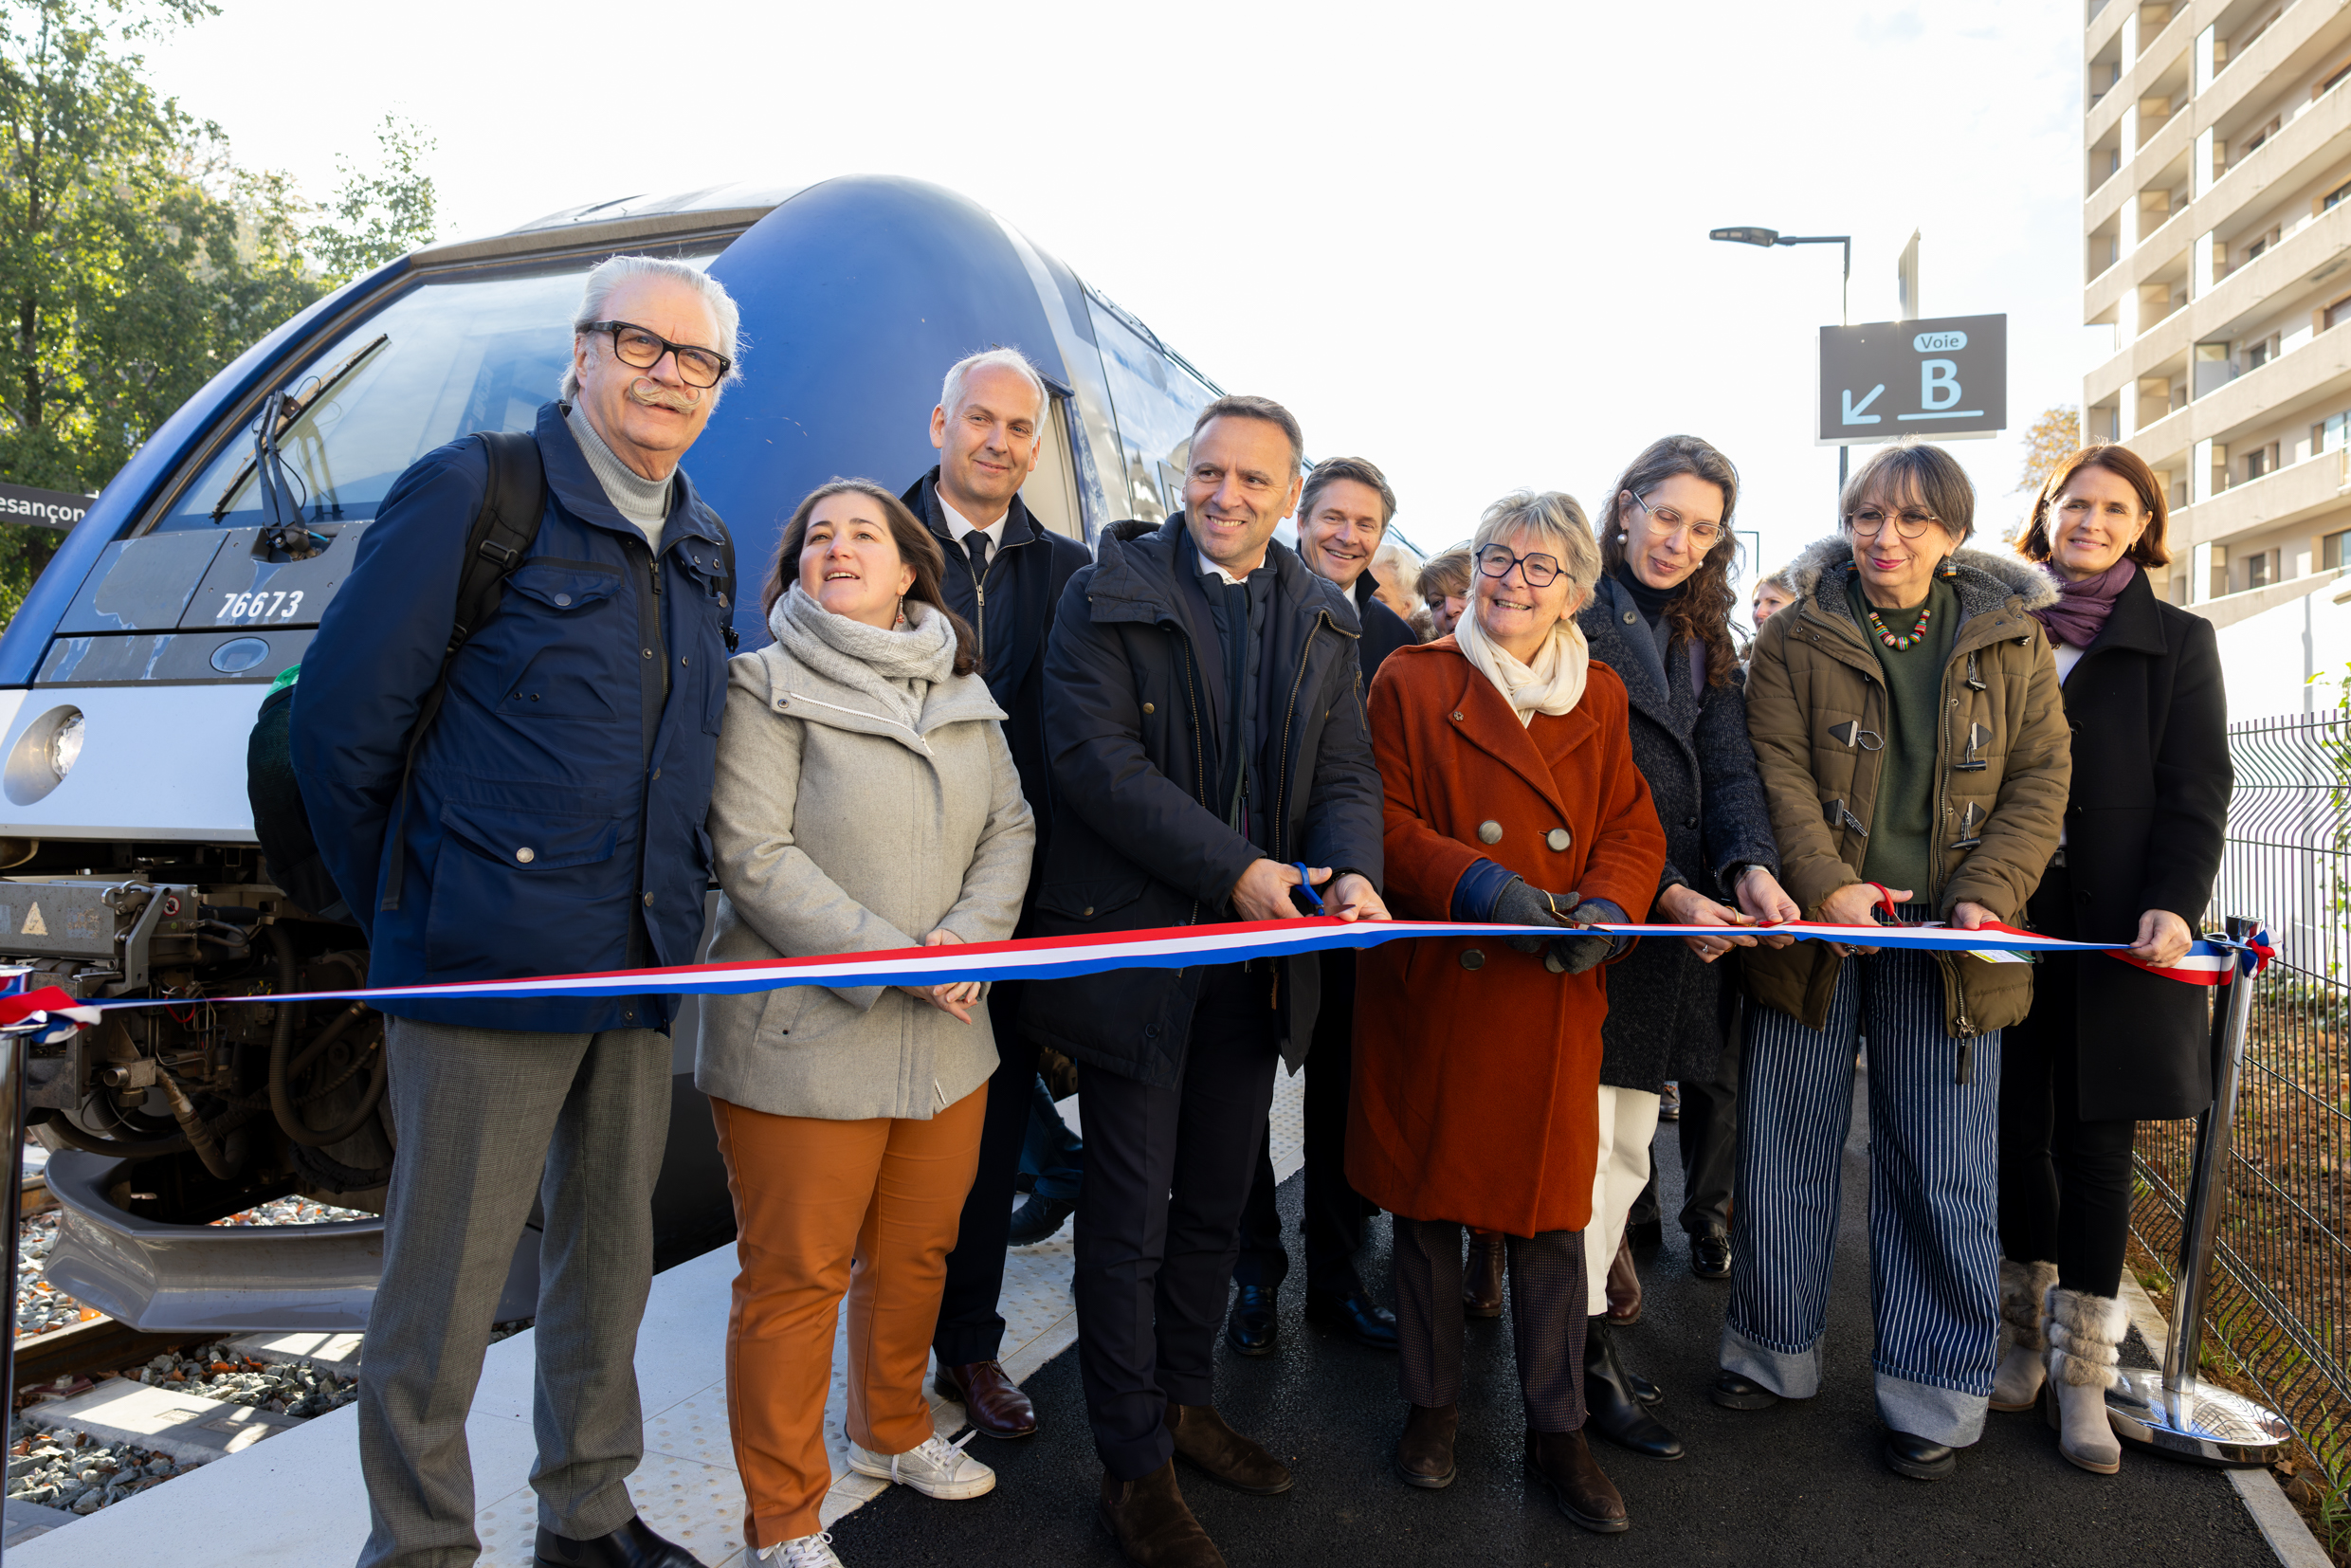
[1721,950,2000,1449]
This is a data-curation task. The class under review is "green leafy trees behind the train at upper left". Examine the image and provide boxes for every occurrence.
[0,0,435,623]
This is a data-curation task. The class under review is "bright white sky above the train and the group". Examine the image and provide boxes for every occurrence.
[148,0,2109,594]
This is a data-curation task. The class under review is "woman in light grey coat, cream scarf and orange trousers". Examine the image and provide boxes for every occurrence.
[694,480,1037,1568]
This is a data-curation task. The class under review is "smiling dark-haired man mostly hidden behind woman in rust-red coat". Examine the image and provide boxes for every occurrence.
[1225,459,1415,1357]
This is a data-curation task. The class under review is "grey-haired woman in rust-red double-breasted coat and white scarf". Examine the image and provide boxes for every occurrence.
[1347,491,1665,1533]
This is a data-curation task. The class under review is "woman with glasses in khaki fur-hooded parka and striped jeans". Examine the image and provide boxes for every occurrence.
[1714,442,2073,1481]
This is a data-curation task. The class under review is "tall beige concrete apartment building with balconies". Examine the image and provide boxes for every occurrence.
[2081,0,2351,717]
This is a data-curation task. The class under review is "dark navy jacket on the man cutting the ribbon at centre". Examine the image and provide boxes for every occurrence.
[1020,513,1385,1086]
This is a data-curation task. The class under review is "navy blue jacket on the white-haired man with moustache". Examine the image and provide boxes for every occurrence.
[294,402,726,1030]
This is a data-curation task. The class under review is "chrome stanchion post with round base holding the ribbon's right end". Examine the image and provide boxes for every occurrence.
[2106,915,2294,1467]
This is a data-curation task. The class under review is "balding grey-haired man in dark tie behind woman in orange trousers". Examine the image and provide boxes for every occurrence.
[905,348,1086,1439]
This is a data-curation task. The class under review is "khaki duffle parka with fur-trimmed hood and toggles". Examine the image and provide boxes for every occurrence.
[1740,536,2073,1037]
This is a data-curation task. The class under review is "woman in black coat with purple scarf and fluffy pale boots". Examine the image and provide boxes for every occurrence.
[1992,447,2232,1474]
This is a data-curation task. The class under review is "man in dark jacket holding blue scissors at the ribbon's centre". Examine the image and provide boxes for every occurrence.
[1020,397,1387,1568]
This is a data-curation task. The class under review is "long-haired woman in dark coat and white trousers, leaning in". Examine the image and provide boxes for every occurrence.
[1577,435,1796,1460]
